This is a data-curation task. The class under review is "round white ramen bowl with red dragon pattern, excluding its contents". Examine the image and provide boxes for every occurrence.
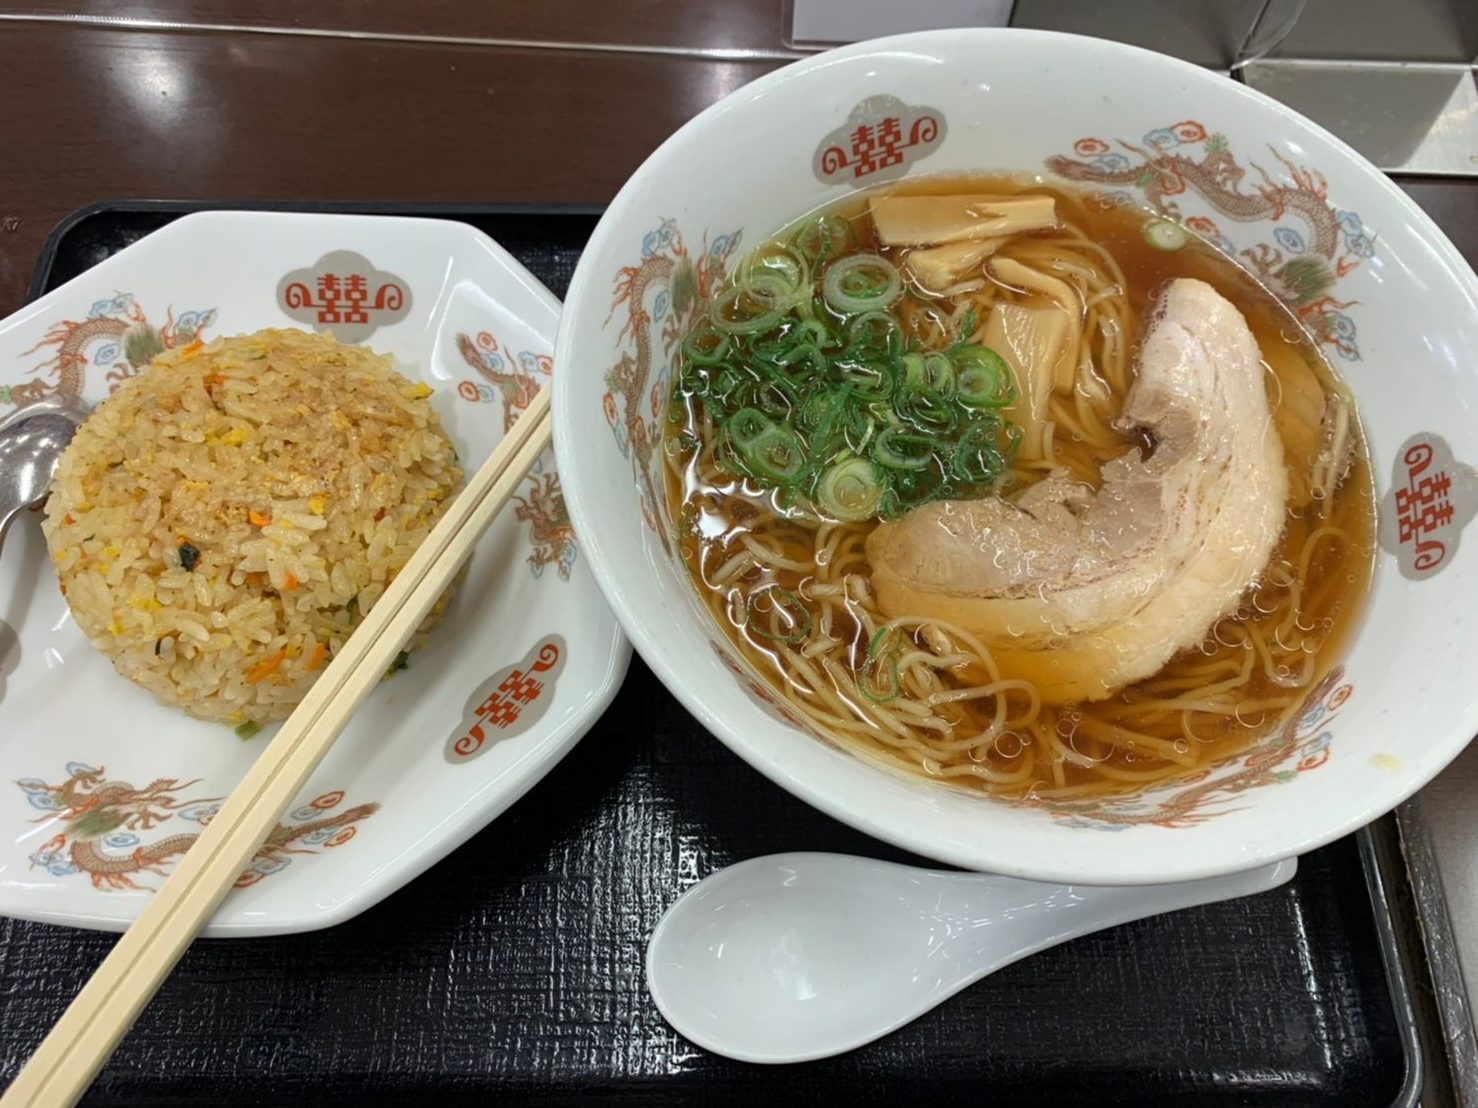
[554,31,1478,883]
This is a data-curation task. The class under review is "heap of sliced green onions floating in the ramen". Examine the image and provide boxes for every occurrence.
[664,224,1021,525]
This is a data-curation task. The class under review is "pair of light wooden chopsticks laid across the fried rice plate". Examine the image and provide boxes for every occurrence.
[0,389,551,1108]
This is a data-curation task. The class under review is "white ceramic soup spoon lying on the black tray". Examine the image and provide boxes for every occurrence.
[647,854,1298,1062]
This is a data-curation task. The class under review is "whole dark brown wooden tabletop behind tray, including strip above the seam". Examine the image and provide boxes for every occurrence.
[0,14,1478,316]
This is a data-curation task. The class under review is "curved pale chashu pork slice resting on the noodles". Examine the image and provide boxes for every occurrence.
[868,279,1287,703]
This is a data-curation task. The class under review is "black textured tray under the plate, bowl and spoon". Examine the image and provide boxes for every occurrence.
[0,202,1420,1108]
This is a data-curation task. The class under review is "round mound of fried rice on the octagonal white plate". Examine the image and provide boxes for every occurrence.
[41,329,463,731]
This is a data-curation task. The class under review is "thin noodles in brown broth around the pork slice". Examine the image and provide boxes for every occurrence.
[662,171,1373,801]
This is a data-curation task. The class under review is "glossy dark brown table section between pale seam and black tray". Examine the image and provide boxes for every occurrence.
[0,16,780,316]
